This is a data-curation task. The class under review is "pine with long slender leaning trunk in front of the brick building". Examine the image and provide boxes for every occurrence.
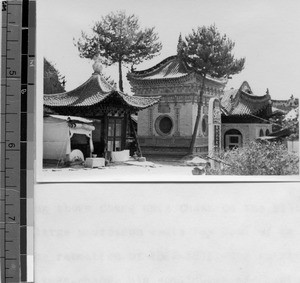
[181,25,245,153]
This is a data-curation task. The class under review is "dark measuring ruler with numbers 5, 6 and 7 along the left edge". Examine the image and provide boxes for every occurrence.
[0,0,36,283]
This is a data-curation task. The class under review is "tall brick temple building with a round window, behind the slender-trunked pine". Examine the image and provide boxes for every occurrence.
[127,52,227,156]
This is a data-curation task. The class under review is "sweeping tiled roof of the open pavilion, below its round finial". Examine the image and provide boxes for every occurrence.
[44,73,160,113]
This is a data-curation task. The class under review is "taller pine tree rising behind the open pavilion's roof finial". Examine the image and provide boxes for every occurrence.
[75,11,162,91]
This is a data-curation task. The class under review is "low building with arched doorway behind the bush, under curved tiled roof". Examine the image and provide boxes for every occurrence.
[221,82,273,149]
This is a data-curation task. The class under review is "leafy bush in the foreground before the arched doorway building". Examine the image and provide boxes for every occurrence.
[207,141,299,175]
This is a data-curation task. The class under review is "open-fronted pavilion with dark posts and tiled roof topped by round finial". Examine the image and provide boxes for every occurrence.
[44,62,159,164]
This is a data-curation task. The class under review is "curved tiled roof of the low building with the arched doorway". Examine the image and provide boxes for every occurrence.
[221,82,271,116]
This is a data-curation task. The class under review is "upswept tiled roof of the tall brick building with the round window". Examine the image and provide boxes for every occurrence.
[127,55,227,84]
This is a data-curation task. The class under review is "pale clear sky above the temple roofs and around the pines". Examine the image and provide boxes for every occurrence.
[37,0,300,99]
